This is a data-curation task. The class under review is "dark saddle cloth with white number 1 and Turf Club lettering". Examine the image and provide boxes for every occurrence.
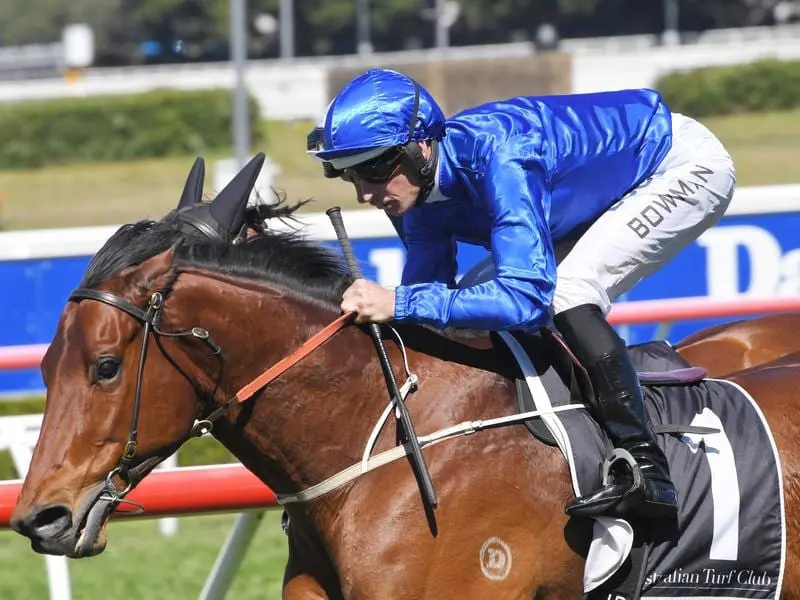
[492,330,786,600]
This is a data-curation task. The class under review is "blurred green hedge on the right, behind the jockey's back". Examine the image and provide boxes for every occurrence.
[655,60,800,117]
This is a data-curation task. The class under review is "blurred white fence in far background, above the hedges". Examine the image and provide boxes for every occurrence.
[0,25,800,120]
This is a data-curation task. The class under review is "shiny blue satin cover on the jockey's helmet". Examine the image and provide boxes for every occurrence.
[312,69,445,160]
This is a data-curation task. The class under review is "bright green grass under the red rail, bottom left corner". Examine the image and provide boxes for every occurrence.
[0,510,286,600]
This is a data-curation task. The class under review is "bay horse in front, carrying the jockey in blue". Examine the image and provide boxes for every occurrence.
[12,157,800,600]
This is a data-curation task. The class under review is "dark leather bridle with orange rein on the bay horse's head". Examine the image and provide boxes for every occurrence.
[68,288,353,505]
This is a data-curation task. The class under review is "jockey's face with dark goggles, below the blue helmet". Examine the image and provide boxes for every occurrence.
[342,142,431,216]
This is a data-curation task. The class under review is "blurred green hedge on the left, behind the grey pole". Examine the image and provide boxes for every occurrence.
[0,89,260,169]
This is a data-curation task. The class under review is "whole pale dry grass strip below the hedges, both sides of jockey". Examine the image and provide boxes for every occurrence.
[0,110,800,229]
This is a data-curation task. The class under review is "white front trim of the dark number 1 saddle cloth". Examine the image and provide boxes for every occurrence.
[498,331,633,593]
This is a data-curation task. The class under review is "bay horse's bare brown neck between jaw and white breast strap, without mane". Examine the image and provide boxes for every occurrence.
[176,277,404,492]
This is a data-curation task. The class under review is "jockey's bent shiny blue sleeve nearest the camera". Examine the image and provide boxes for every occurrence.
[395,140,556,331]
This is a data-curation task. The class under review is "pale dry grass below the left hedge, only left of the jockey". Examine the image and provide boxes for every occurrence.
[0,122,357,230]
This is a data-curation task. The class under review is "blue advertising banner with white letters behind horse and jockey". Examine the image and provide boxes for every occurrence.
[0,212,800,393]
